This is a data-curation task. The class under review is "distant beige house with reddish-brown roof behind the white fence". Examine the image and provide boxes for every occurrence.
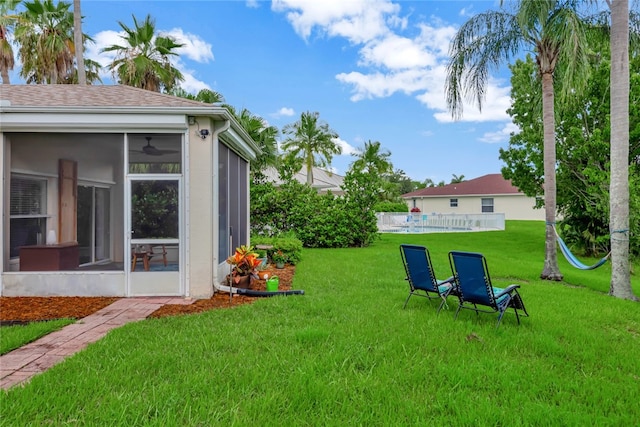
[402,173,544,220]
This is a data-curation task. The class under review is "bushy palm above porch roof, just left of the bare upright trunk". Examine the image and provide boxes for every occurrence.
[15,0,74,84]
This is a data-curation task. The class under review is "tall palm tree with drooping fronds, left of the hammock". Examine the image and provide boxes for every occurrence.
[446,0,589,280]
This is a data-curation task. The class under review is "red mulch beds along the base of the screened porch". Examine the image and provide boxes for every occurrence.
[0,264,295,323]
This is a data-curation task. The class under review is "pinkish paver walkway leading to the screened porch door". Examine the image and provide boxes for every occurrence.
[0,297,195,389]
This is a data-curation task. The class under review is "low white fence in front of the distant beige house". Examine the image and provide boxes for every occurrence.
[376,212,504,233]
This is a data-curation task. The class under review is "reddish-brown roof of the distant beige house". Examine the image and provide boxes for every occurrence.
[402,173,523,199]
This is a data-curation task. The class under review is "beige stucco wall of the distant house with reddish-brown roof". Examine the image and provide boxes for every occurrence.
[407,195,544,220]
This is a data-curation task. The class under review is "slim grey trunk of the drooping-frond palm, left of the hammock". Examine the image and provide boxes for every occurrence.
[540,72,562,280]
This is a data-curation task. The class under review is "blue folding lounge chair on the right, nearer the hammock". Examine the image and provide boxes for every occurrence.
[449,251,529,328]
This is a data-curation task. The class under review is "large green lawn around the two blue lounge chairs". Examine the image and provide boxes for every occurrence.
[0,222,640,426]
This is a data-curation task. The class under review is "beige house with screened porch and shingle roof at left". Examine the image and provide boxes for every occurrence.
[0,85,259,298]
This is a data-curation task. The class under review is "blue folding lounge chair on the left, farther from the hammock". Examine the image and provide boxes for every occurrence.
[400,244,454,313]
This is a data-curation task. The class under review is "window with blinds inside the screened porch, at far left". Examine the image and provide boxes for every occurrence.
[9,175,47,258]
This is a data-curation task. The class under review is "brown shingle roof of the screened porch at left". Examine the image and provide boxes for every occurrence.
[0,84,219,108]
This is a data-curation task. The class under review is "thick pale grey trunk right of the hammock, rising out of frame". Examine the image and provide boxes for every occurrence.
[609,0,638,300]
